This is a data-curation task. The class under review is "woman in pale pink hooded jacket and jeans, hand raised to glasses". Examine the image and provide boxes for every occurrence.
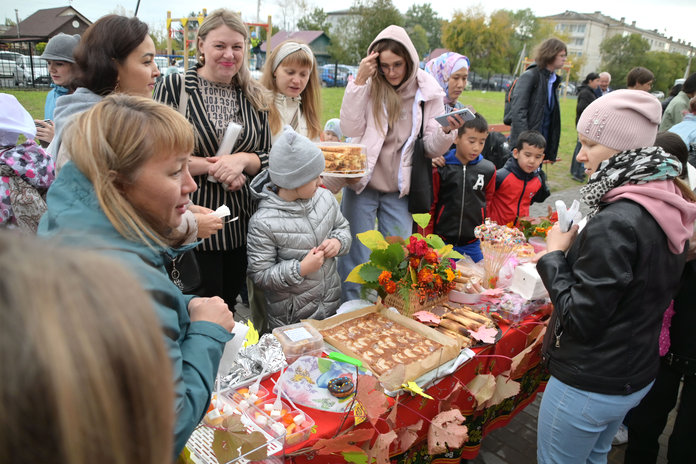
[324,26,463,301]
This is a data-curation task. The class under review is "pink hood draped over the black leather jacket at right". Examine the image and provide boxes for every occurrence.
[602,180,696,254]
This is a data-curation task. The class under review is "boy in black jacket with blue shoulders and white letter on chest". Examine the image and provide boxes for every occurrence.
[431,114,495,262]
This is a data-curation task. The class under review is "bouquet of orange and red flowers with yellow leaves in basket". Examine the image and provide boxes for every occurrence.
[346,214,462,313]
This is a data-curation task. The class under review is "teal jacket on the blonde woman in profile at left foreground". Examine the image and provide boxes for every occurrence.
[38,162,232,455]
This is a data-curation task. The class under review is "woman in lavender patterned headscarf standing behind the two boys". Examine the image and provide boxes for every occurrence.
[425,52,475,167]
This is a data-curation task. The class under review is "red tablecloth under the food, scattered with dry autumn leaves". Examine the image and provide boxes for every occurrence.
[276,313,548,464]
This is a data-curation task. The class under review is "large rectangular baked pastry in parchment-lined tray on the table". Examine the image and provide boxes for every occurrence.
[320,313,442,375]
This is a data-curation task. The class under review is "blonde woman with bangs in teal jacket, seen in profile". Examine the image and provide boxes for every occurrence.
[39,95,234,453]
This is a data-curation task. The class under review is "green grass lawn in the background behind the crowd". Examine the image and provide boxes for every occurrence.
[2,87,578,192]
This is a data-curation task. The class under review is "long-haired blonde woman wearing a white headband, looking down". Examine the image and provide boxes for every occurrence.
[261,40,321,141]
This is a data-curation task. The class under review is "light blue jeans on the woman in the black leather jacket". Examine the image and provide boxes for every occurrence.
[537,376,653,464]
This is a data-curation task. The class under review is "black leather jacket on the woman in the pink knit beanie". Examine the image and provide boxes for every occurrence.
[537,200,686,395]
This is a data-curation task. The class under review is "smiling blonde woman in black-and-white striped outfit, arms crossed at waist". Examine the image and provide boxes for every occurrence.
[155,9,271,308]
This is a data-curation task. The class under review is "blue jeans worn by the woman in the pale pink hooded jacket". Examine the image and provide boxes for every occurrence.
[338,187,413,302]
